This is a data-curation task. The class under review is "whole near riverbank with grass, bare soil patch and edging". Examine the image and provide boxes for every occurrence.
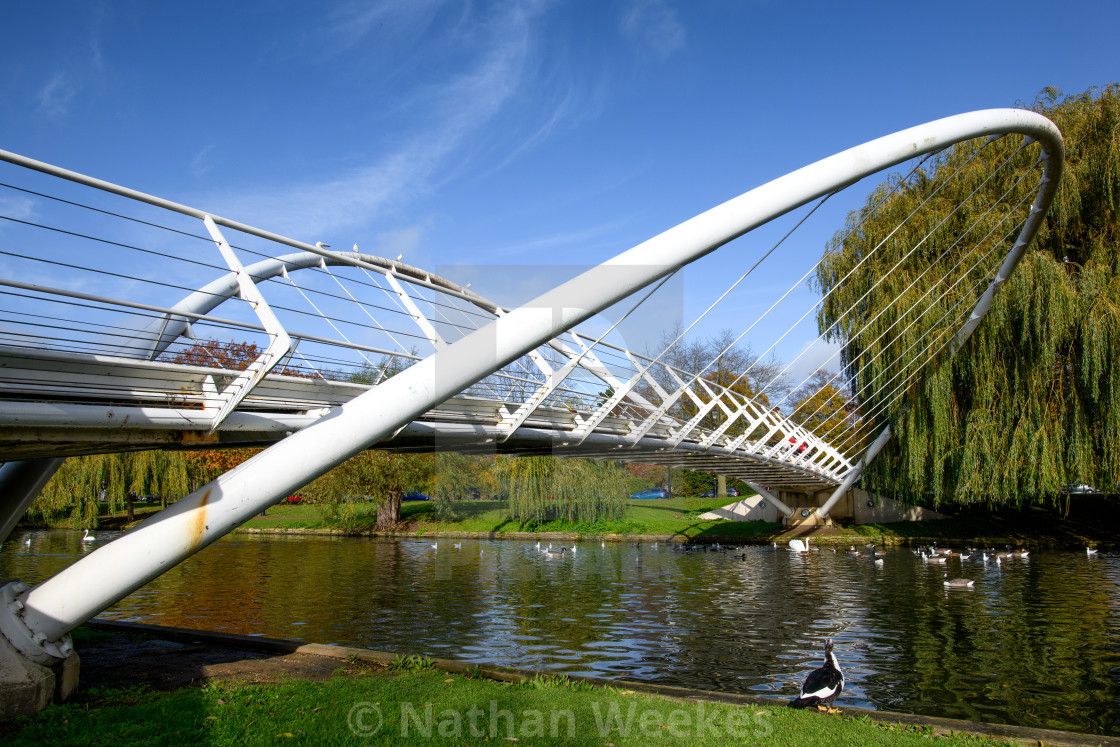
[0,620,1120,747]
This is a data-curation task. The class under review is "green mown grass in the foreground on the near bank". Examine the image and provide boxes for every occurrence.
[0,657,1006,747]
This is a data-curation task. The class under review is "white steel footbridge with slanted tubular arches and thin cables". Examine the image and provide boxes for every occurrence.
[0,110,1063,712]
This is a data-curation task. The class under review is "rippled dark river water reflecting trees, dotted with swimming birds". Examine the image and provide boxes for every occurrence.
[0,531,1120,735]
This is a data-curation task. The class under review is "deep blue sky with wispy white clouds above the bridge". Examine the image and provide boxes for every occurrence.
[0,0,1120,380]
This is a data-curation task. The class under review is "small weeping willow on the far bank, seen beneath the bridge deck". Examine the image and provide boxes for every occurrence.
[496,456,627,524]
